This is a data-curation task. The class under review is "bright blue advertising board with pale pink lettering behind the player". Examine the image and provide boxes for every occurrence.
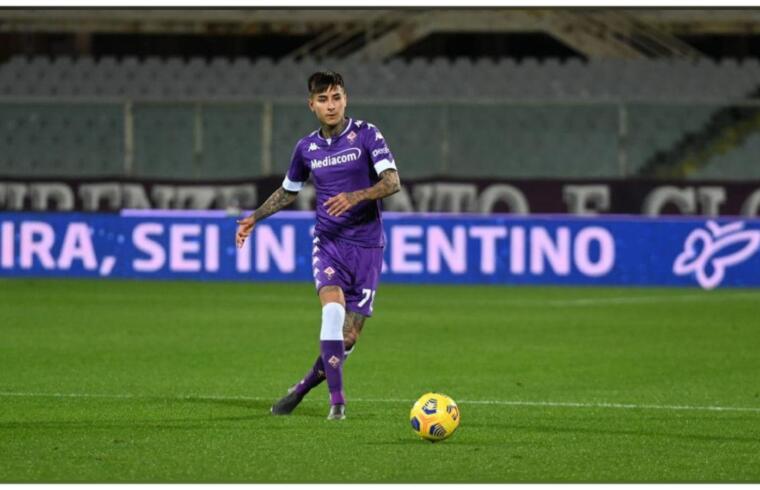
[0,211,760,289]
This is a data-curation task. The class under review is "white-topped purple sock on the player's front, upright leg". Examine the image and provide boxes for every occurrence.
[319,303,346,405]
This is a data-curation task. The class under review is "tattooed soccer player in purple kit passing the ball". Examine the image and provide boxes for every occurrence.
[235,71,401,420]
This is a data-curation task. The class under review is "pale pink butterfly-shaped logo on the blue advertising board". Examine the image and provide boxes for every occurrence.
[673,220,760,289]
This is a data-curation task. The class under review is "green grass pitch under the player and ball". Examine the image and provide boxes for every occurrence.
[0,280,760,482]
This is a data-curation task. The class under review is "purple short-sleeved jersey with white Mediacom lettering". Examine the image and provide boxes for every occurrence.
[282,119,396,247]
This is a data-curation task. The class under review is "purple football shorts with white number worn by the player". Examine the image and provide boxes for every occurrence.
[311,235,383,316]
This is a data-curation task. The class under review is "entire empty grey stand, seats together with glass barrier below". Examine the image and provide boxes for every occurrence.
[0,56,760,179]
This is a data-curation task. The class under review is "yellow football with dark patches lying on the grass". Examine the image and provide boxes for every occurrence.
[409,393,460,442]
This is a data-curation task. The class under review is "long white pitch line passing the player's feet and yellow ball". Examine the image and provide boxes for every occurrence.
[0,392,760,413]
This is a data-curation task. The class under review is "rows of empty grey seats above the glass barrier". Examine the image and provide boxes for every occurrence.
[0,56,760,101]
